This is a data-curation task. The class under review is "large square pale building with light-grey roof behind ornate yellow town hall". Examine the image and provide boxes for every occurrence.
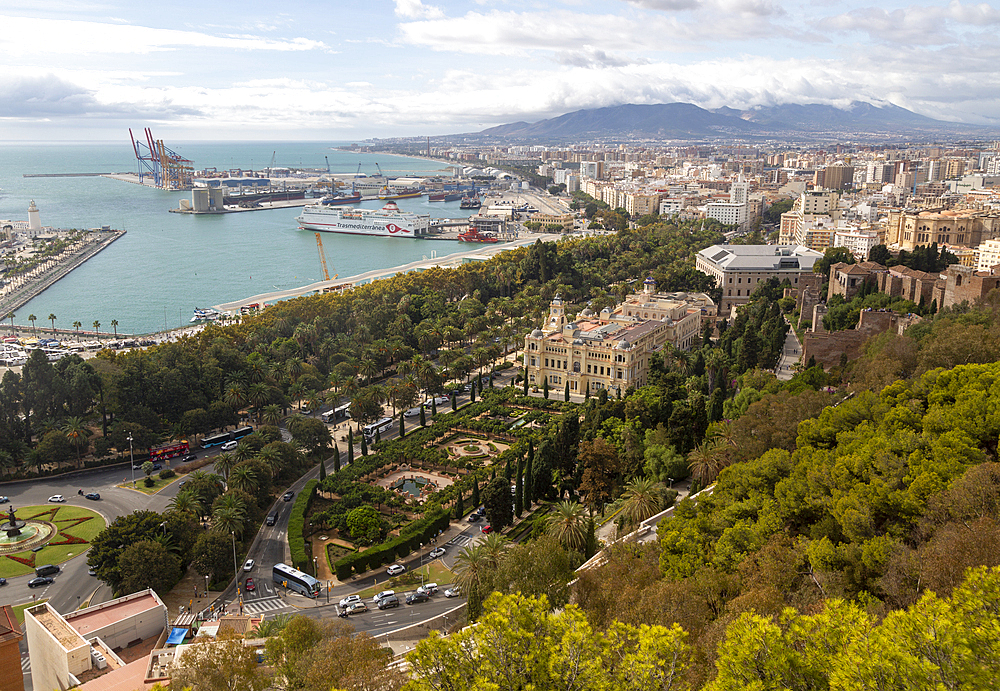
[695,245,823,317]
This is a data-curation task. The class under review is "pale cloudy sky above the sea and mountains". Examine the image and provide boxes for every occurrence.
[0,0,1000,140]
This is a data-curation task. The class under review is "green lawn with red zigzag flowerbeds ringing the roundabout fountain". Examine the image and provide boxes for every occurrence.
[0,504,105,578]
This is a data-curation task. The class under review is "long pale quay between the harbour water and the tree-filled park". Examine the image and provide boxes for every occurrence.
[214,233,562,312]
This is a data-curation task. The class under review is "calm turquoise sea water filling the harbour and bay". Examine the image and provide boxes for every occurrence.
[0,137,472,334]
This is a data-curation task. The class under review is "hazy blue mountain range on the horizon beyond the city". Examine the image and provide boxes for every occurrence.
[476,101,987,140]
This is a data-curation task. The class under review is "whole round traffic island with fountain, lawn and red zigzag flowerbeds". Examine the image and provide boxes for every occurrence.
[0,505,105,578]
